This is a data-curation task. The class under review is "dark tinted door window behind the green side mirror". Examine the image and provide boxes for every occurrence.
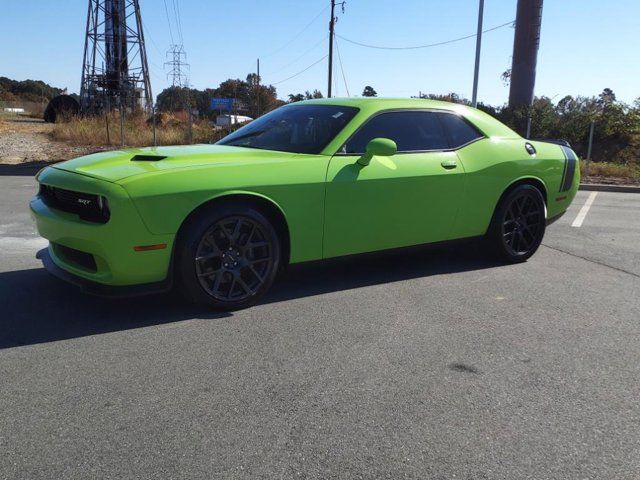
[344,111,449,154]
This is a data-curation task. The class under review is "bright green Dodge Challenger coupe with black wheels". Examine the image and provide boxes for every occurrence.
[31,99,580,310]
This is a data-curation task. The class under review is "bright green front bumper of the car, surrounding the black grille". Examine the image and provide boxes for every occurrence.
[30,167,175,287]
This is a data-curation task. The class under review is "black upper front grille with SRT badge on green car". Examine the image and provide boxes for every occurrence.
[39,184,110,223]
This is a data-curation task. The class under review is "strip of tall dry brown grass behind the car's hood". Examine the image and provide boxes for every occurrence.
[51,112,225,147]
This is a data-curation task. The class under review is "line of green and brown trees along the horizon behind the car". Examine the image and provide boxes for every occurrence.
[0,73,640,165]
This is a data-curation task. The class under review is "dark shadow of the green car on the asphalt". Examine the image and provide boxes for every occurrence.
[0,244,497,349]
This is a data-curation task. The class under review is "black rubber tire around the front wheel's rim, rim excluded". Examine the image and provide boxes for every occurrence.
[174,204,281,310]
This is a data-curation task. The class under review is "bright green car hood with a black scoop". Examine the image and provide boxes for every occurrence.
[53,145,298,182]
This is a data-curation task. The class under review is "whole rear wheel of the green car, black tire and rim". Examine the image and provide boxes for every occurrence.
[486,184,546,263]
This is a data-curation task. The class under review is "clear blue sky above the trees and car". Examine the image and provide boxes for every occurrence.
[0,0,640,105]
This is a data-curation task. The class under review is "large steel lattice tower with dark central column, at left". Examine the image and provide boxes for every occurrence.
[80,0,153,113]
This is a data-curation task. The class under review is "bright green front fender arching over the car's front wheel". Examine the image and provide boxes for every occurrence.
[122,156,328,263]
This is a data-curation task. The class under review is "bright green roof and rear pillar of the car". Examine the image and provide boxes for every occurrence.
[287,97,520,138]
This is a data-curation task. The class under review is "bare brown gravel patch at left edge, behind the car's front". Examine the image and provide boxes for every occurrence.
[0,117,104,165]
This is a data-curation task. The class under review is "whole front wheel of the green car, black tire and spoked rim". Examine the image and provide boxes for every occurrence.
[175,203,281,311]
